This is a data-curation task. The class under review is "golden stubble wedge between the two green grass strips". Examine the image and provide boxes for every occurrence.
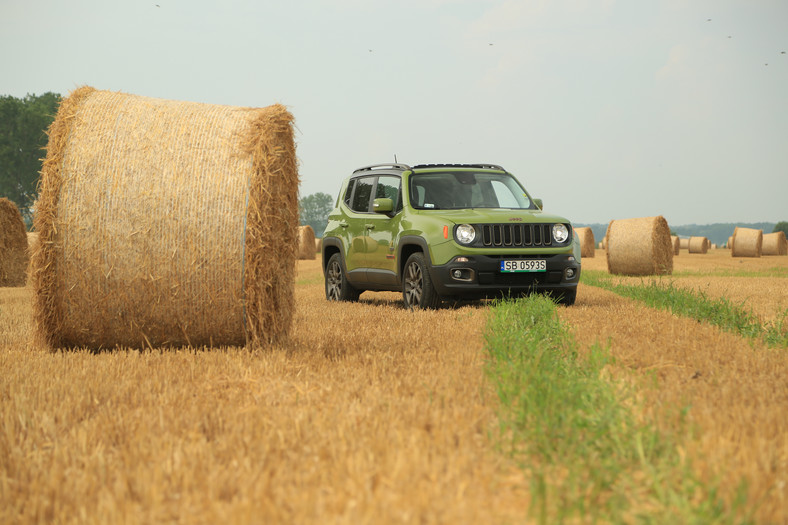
[558,284,788,523]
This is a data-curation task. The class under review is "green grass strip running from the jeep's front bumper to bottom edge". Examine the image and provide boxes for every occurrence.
[485,295,744,523]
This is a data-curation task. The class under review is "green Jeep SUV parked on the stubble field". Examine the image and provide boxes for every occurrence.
[322,164,580,308]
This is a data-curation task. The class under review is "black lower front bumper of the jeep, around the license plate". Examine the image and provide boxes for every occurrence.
[430,253,580,298]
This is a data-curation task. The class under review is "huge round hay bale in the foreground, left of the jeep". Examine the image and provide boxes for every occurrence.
[32,87,298,348]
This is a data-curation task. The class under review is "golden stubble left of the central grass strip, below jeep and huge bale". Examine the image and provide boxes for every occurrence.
[0,261,527,523]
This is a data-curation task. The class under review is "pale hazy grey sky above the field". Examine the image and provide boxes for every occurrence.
[0,0,788,225]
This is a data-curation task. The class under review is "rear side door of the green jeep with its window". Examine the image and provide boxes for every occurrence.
[339,176,376,282]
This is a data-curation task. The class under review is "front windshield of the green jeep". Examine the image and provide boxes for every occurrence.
[410,171,536,210]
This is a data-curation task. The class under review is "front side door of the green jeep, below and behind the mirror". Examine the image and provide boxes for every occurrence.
[366,175,402,285]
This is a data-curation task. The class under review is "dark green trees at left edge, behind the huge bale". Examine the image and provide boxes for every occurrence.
[0,92,61,229]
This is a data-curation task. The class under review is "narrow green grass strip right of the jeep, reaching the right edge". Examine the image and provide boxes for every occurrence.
[581,270,788,347]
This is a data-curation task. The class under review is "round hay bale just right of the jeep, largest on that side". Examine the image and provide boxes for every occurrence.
[607,215,673,275]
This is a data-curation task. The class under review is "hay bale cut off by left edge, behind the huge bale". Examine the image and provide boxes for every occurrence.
[0,197,30,287]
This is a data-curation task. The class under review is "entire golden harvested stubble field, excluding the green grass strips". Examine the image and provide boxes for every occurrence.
[0,250,788,523]
